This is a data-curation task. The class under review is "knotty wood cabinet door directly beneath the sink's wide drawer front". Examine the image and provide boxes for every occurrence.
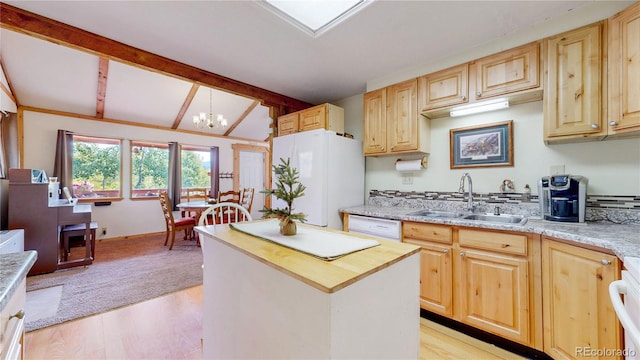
[458,248,532,345]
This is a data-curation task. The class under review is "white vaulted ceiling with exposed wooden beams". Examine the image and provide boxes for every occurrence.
[0,1,629,141]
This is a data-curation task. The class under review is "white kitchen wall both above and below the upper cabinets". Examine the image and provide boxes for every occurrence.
[336,1,640,195]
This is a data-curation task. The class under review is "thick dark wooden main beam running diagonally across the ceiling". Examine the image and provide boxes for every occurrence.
[0,2,313,111]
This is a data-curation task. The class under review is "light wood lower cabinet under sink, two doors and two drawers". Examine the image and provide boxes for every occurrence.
[403,222,542,350]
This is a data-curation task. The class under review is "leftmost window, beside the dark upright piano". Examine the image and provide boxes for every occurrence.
[72,135,122,200]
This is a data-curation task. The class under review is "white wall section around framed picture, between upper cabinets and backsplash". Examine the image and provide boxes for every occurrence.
[365,101,640,195]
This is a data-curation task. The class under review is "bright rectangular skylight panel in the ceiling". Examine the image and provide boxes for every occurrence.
[264,0,372,37]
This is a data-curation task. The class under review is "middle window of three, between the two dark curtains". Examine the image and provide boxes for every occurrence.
[131,141,169,199]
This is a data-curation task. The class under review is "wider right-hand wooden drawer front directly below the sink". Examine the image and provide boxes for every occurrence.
[458,229,527,255]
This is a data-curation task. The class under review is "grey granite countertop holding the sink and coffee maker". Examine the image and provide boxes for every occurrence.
[340,205,640,261]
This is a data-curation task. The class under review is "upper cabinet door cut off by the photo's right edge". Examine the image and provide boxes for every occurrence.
[609,3,640,134]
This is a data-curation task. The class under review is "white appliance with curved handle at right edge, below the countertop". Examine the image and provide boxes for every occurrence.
[609,257,640,360]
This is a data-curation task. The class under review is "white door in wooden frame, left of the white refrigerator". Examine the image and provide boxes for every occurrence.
[232,144,271,220]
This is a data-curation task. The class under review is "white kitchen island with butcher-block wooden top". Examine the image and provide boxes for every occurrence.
[196,221,420,359]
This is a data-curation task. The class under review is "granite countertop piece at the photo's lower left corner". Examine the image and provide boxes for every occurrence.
[0,250,38,311]
